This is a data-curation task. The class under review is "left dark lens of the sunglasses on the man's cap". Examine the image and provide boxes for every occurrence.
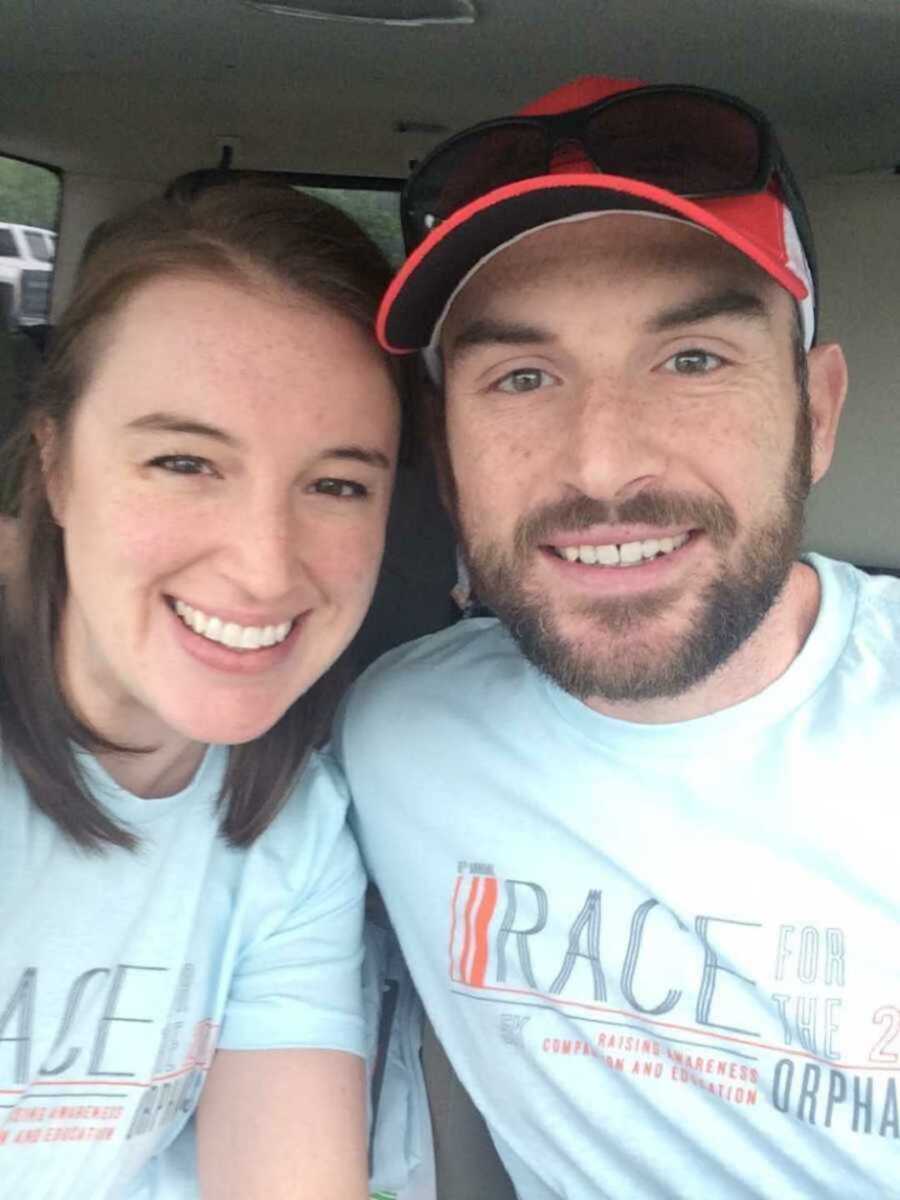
[406,122,548,250]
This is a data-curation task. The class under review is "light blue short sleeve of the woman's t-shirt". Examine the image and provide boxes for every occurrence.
[218,755,366,1055]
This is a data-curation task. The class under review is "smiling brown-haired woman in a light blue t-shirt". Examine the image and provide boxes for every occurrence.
[0,185,400,1200]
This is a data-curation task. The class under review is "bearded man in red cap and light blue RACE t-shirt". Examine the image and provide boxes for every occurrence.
[336,79,900,1200]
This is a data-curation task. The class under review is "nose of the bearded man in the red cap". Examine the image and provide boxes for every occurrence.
[562,380,668,500]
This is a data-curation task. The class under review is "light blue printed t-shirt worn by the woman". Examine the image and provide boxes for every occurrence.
[0,748,365,1200]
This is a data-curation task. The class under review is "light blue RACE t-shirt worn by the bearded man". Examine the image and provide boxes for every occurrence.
[336,557,900,1200]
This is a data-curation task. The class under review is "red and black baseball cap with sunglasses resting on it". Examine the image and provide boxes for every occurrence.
[377,76,816,354]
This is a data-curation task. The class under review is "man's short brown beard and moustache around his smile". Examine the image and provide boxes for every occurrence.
[463,400,810,702]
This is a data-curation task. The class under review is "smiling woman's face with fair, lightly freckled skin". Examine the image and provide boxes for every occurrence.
[50,277,400,746]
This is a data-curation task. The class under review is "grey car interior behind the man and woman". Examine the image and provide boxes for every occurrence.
[0,0,900,1200]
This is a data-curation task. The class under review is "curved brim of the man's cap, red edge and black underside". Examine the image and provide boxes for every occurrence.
[376,173,808,354]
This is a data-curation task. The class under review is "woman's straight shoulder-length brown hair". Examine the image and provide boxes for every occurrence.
[0,178,402,850]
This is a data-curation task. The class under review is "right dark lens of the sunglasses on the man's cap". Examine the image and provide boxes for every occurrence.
[584,91,762,196]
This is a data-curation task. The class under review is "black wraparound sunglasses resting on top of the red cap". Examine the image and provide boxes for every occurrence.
[401,84,815,277]
